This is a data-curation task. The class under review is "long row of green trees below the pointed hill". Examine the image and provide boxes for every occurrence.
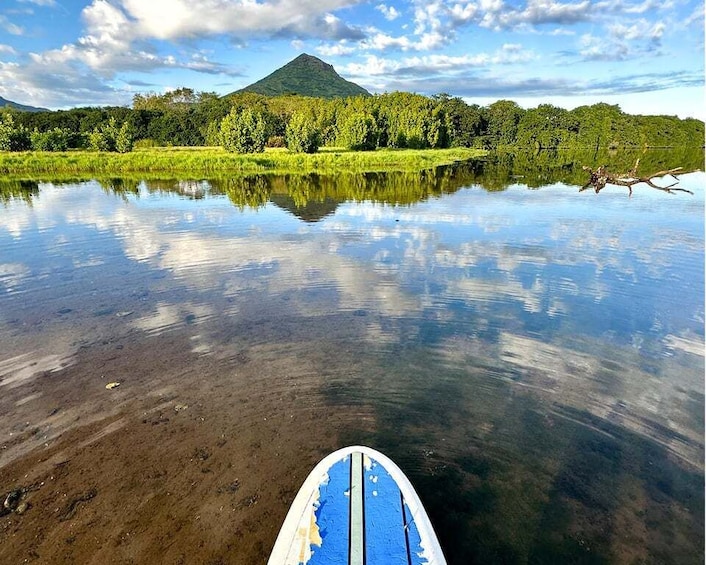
[0,88,704,152]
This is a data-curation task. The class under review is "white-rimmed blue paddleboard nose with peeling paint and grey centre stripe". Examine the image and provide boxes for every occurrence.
[268,446,446,565]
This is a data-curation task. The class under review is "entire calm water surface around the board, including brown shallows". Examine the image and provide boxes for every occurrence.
[0,152,706,565]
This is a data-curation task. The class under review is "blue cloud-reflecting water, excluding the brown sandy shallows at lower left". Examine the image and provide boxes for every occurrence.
[0,161,706,564]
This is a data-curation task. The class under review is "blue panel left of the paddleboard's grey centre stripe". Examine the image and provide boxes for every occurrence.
[307,455,351,565]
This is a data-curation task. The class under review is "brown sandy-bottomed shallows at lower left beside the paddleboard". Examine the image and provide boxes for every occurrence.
[0,326,358,563]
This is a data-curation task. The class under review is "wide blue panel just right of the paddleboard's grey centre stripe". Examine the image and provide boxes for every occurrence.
[364,454,408,565]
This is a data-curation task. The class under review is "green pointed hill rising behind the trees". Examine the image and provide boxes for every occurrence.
[237,53,370,98]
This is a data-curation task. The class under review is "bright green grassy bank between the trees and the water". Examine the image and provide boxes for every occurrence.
[0,147,485,178]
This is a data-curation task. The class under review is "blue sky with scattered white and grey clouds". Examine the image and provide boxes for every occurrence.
[0,0,706,120]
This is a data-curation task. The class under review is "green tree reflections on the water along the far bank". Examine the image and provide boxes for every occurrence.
[0,148,704,209]
